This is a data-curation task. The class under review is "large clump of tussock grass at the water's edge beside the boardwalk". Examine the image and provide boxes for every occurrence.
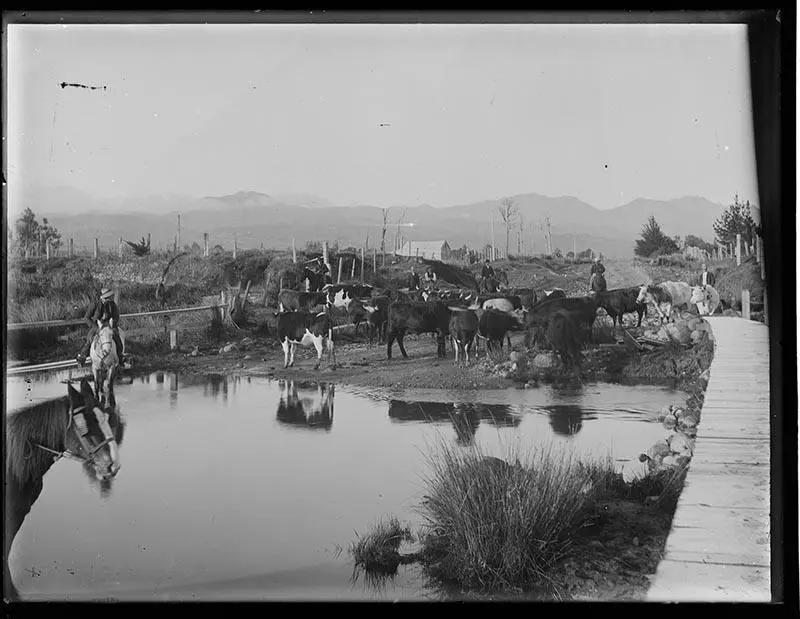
[420,441,615,590]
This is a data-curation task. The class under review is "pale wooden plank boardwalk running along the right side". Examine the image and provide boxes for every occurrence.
[646,317,772,602]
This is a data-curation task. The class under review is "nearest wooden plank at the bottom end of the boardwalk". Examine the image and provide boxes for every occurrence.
[647,560,772,602]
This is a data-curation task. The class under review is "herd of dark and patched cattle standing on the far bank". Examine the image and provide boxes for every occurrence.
[275,282,719,369]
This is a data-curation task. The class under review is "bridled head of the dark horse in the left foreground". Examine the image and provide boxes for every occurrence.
[64,379,121,481]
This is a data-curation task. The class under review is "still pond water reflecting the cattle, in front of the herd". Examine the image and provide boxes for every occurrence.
[7,373,682,600]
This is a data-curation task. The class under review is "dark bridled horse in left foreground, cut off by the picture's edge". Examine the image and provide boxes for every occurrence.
[3,379,123,600]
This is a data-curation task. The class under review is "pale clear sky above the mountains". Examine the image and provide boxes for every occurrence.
[6,24,758,214]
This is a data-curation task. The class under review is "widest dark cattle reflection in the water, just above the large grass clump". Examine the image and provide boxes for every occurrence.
[389,400,522,445]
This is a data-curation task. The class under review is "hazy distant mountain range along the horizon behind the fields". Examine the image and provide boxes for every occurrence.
[25,190,725,258]
